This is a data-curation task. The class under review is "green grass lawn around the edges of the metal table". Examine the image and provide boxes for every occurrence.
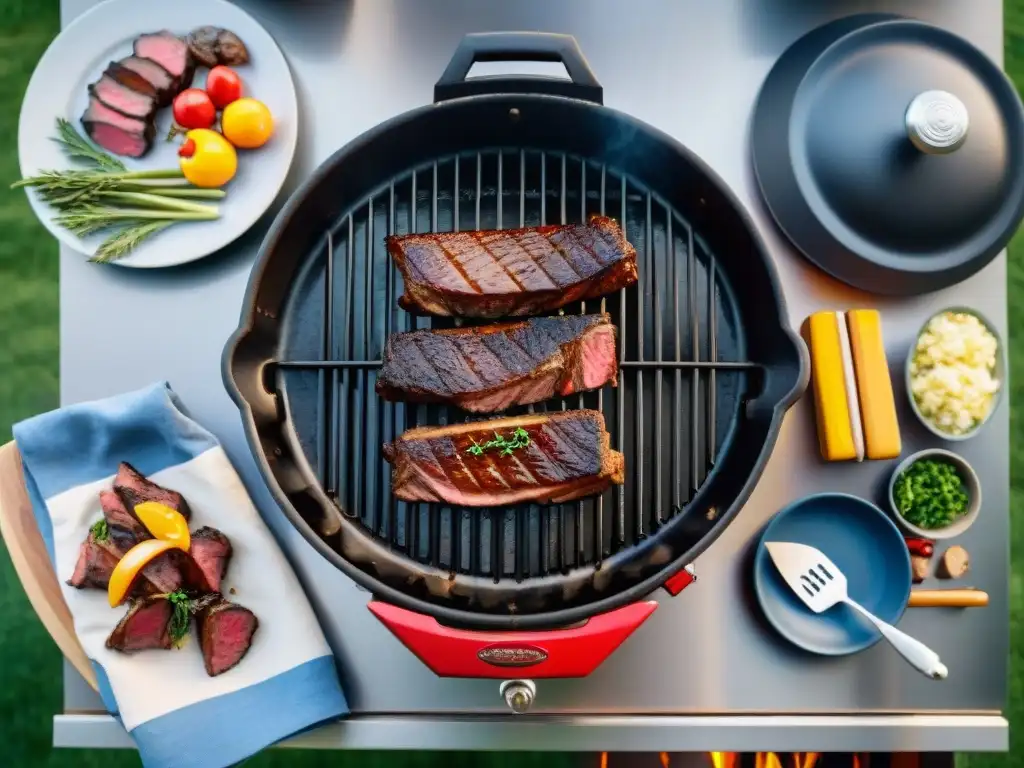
[0,0,1024,768]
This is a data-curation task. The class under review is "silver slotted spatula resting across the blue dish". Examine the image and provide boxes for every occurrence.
[765,542,948,680]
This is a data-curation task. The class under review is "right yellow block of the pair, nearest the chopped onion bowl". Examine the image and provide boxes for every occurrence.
[846,309,902,459]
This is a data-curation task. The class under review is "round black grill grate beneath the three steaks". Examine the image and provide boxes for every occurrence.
[278,150,760,582]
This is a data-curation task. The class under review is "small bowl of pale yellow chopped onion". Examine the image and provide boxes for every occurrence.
[906,307,1007,440]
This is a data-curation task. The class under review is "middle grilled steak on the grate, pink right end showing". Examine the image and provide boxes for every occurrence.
[377,314,618,413]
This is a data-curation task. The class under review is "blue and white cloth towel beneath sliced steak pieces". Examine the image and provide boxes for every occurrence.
[14,383,348,768]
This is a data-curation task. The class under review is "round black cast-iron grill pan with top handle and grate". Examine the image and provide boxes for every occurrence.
[224,28,807,676]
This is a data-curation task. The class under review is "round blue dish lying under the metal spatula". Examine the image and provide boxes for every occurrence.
[754,494,910,656]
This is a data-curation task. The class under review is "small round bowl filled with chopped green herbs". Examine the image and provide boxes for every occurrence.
[889,449,981,540]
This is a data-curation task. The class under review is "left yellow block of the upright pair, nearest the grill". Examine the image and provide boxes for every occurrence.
[802,311,863,462]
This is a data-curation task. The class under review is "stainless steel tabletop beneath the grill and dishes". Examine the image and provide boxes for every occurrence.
[54,0,1009,751]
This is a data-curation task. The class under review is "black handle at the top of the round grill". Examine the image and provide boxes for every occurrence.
[434,32,604,104]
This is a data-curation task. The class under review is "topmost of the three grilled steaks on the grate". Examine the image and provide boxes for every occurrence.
[385,216,637,317]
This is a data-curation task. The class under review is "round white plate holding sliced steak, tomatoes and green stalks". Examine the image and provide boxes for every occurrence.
[17,0,298,267]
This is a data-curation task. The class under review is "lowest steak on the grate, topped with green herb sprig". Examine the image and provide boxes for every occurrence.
[384,411,625,507]
